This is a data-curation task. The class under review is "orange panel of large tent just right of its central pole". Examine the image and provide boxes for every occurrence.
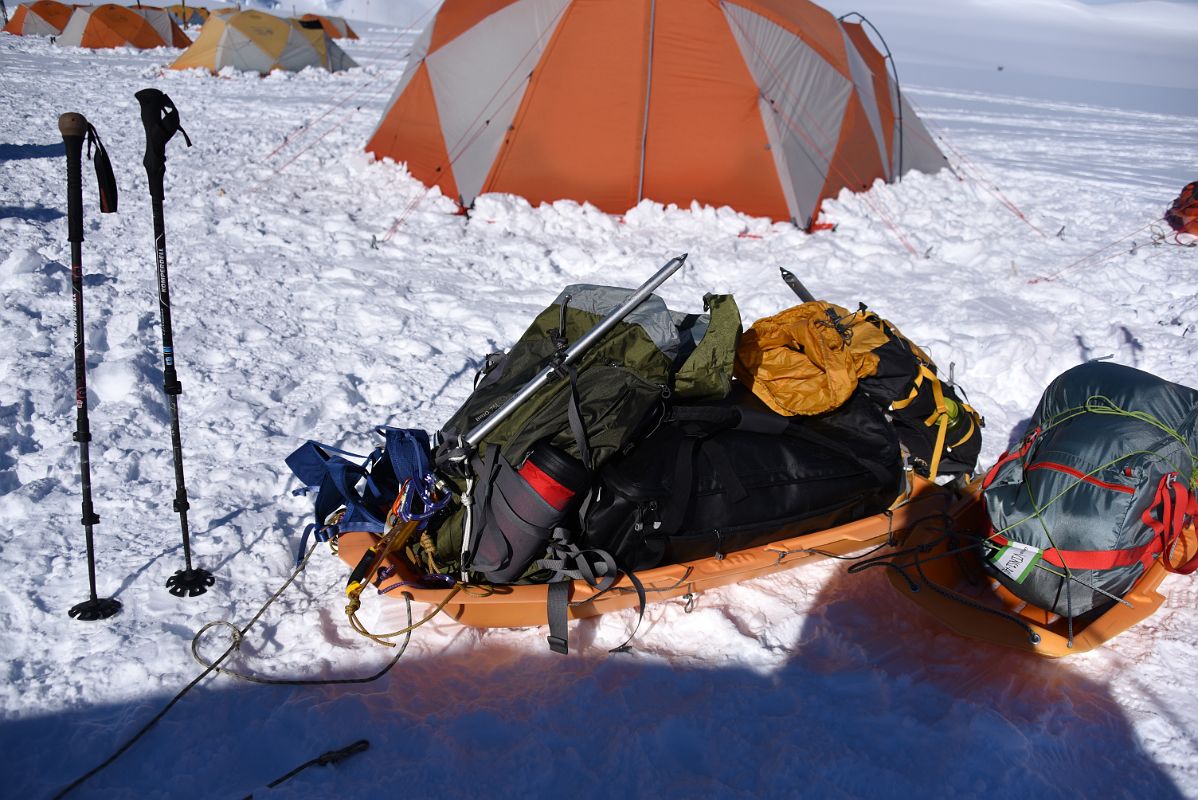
[645,0,791,219]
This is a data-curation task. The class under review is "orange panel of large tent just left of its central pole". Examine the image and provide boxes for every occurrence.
[483,0,651,213]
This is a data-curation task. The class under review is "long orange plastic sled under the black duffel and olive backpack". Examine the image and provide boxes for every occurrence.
[338,475,956,628]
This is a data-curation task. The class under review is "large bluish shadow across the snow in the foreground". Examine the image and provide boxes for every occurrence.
[0,562,1181,800]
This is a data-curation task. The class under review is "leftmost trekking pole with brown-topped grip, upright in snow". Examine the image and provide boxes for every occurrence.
[59,111,121,620]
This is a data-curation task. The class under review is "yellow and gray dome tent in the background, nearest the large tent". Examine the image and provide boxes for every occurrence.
[170,11,358,74]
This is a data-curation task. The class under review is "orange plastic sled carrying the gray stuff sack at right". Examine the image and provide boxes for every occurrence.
[888,483,1198,657]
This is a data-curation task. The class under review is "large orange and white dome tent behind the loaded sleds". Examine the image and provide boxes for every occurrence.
[367,0,945,228]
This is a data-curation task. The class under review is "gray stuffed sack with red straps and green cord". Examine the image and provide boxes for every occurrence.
[982,362,1198,618]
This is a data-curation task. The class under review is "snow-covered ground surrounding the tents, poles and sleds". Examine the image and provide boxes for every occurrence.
[0,0,1198,799]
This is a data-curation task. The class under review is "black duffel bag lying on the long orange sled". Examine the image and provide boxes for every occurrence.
[580,389,903,571]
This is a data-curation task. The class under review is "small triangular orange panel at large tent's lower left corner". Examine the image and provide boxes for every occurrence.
[367,63,458,200]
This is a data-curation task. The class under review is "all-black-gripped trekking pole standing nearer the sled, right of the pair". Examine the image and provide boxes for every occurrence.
[134,89,216,598]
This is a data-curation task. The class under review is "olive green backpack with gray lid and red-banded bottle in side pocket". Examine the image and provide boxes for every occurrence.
[419,284,740,583]
